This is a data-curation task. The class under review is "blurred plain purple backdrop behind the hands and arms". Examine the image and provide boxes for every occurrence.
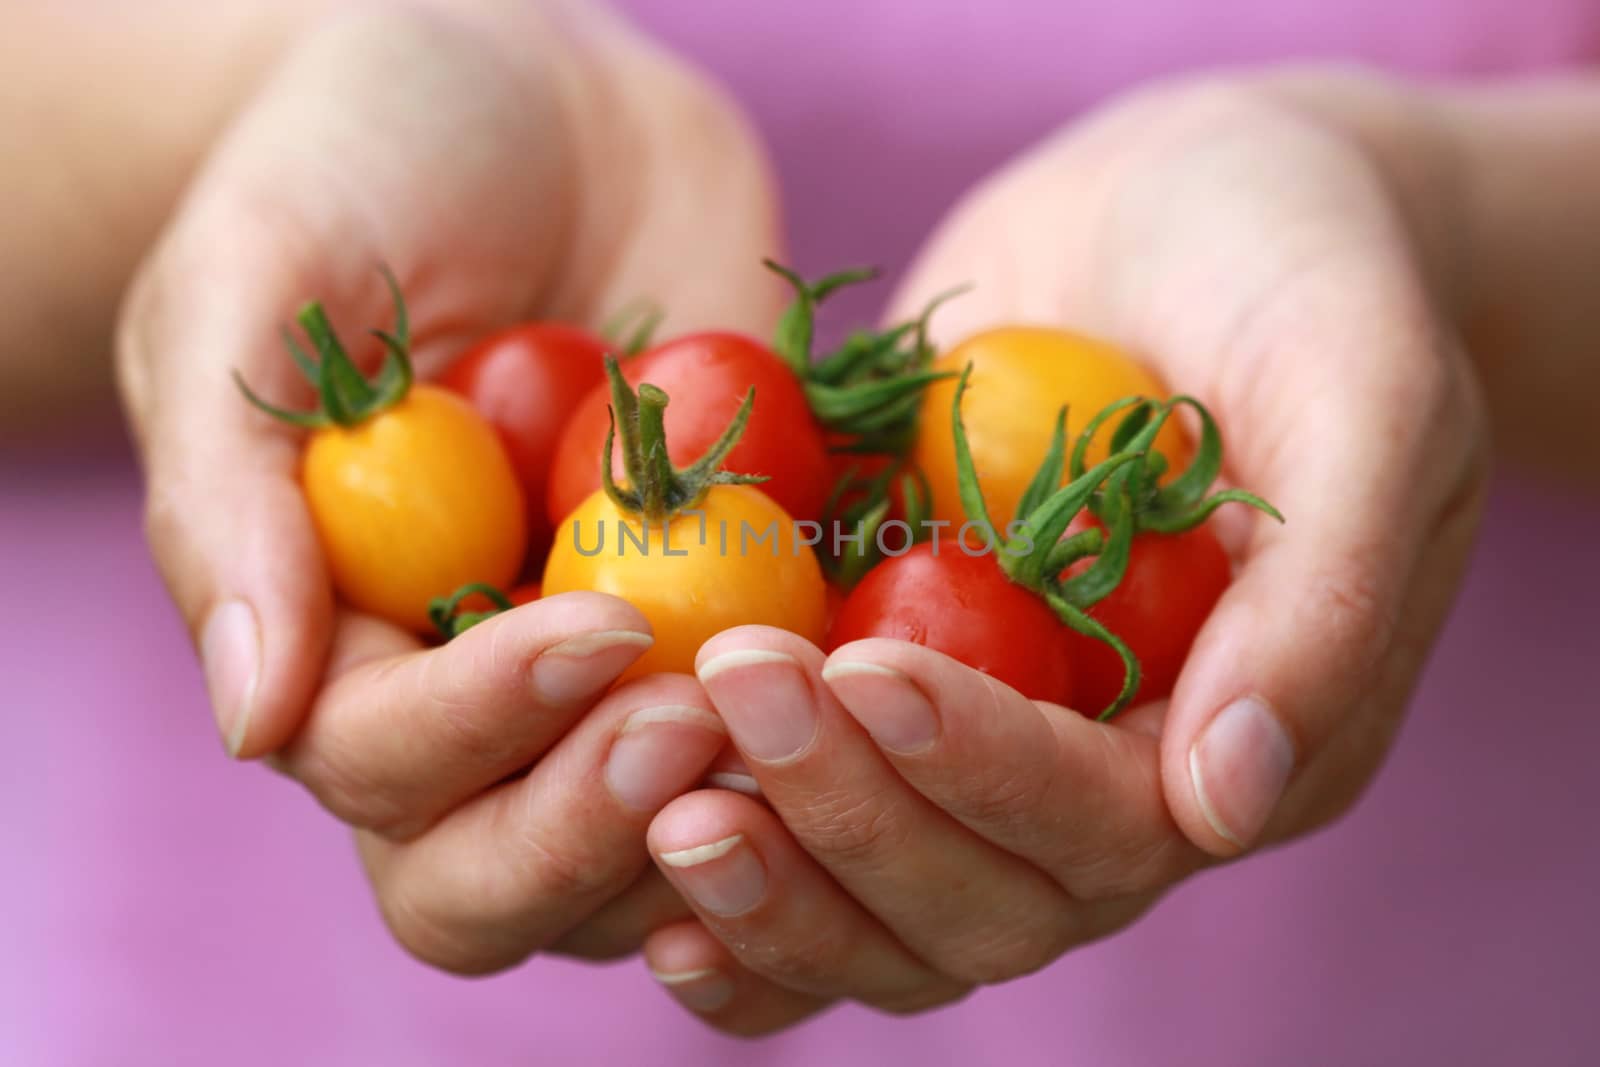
[12,0,1600,1067]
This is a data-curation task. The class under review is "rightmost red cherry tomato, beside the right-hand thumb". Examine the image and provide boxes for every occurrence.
[1067,520,1232,709]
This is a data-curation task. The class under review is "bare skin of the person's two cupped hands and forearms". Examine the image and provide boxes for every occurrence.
[0,0,1600,1033]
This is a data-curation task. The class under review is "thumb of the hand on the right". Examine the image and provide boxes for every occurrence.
[1163,396,1482,854]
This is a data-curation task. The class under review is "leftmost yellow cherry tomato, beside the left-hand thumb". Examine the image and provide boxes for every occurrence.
[301,384,526,632]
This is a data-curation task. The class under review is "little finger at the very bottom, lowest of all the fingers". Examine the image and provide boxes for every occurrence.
[645,920,830,1037]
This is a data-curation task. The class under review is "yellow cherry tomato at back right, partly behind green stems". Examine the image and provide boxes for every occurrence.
[912,326,1189,528]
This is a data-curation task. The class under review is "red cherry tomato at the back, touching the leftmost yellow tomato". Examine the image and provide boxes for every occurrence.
[440,322,610,559]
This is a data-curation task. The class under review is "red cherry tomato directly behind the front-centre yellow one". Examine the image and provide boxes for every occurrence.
[546,333,832,525]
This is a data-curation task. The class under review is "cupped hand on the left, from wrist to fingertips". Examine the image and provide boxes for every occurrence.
[118,0,782,973]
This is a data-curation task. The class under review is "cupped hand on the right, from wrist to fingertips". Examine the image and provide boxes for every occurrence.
[646,68,1486,1032]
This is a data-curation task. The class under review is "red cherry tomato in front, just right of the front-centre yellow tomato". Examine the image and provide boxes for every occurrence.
[827,537,1075,707]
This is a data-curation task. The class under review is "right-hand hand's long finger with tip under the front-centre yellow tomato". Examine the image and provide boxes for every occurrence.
[696,627,1082,982]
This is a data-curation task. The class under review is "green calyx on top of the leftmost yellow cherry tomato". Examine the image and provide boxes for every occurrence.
[234,267,413,429]
